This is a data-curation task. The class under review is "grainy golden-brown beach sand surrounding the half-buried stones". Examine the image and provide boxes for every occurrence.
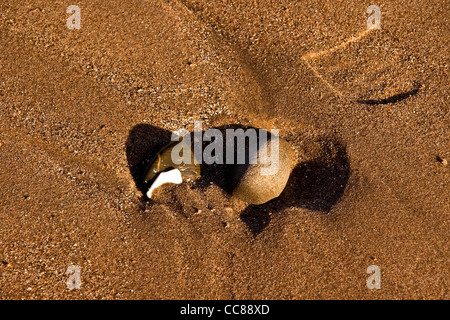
[0,0,450,299]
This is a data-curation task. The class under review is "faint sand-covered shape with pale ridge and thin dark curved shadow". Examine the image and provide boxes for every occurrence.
[302,29,420,104]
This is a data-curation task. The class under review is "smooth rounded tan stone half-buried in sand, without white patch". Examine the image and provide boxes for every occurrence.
[232,135,294,204]
